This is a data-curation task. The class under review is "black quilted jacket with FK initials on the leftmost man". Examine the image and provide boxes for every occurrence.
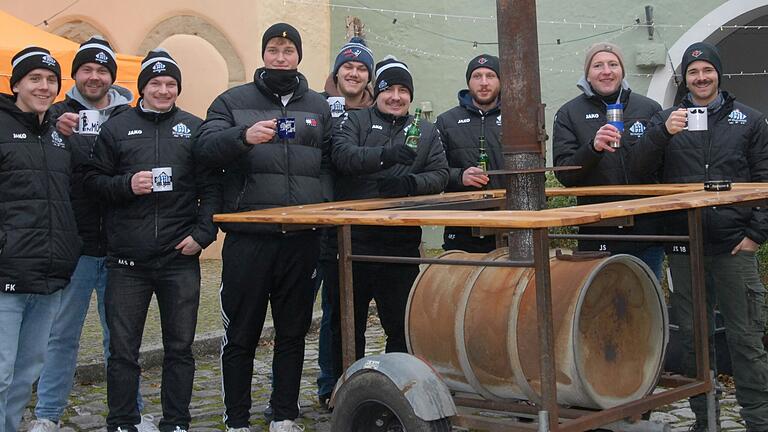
[0,95,82,294]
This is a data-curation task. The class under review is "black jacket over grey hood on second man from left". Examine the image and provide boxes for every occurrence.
[49,96,131,257]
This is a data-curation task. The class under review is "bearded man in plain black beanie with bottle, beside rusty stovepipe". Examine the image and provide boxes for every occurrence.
[435,54,504,252]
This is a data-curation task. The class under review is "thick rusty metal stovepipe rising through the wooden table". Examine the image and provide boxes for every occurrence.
[496,0,547,259]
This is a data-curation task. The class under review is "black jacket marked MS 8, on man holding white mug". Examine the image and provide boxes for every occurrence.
[85,106,220,269]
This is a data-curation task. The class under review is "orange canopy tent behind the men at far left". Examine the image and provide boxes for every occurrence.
[0,11,141,100]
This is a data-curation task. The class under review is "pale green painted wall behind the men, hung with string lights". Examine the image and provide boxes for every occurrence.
[331,0,725,157]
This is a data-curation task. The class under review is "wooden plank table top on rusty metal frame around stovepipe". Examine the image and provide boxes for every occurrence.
[214,183,768,432]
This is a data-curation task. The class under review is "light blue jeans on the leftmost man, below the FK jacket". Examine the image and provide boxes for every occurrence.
[0,291,62,432]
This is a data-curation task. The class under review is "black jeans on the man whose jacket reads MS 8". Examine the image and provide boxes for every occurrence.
[104,256,200,432]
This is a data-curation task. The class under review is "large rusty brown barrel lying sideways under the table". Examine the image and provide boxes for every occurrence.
[406,249,668,408]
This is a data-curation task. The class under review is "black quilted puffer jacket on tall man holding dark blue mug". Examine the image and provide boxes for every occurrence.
[195,69,332,234]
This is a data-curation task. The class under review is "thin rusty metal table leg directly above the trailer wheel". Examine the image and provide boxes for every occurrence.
[338,225,356,370]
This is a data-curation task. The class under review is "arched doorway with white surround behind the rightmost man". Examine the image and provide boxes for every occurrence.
[648,0,768,112]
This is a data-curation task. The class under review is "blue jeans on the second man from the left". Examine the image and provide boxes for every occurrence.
[35,255,144,423]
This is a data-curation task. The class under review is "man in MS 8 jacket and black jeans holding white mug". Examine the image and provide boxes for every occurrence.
[85,50,219,432]
